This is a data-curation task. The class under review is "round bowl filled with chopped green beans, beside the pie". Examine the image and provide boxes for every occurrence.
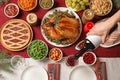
[27,40,48,60]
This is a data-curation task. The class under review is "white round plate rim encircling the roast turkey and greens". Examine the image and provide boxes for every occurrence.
[41,7,82,47]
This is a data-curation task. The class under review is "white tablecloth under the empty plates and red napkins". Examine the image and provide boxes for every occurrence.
[0,57,120,80]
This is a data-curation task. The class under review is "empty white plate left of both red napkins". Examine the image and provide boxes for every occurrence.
[21,66,48,80]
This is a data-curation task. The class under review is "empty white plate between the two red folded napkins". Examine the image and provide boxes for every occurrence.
[69,66,97,80]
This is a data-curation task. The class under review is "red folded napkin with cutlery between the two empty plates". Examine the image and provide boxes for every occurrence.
[47,63,60,80]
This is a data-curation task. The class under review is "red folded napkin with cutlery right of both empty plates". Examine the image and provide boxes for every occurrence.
[95,61,107,80]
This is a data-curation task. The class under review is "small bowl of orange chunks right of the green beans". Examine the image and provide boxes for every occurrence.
[49,47,63,62]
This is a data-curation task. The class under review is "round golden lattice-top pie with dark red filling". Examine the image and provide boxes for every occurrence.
[0,19,33,51]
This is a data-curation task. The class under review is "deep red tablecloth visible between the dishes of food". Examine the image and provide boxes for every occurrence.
[0,0,120,57]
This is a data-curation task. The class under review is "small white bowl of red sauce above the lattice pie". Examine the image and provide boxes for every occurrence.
[4,3,19,18]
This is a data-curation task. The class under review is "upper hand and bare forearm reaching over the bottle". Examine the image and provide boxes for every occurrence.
[87,10,120,43]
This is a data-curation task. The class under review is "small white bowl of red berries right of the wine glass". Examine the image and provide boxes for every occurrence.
[83,52,97,65]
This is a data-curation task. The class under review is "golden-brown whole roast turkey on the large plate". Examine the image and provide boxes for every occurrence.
[42,13,80,43]
